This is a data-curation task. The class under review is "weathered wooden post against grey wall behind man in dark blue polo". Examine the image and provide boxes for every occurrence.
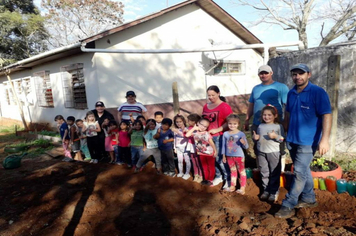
[327,55,341,160]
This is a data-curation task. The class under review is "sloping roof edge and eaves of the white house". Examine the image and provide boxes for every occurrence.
[0,0,263,75]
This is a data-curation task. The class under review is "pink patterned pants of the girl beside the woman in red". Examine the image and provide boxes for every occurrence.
[226,156,247,188]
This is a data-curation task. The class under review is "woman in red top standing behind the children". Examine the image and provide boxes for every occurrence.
[202,85,232,189]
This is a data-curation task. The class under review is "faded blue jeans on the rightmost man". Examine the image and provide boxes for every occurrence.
[282,143,316,208]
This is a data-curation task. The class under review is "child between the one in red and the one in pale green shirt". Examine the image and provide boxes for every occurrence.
[129,119,143,168]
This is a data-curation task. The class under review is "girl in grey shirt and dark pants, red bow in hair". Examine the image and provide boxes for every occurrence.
[253,104,284,202]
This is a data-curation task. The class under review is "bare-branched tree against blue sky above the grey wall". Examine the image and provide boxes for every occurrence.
[232,0,356,48]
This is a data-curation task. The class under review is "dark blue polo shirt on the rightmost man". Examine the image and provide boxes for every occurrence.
[286,81,331,146]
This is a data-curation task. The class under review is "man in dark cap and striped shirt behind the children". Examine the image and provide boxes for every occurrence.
[117,91,147,123]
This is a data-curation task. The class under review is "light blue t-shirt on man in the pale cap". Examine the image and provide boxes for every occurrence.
[248,81,289,125]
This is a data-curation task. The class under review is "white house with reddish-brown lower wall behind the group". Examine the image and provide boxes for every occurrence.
[0,0,263,129]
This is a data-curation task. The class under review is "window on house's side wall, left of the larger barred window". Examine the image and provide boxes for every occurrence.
[33,71,54,107]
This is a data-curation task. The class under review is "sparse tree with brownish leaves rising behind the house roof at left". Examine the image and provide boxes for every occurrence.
[41,0,124,47]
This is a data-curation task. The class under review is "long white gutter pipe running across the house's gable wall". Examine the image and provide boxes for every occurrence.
[80,41,303,64]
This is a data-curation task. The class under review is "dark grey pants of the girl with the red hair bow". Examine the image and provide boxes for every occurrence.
[257,152,281,194]
